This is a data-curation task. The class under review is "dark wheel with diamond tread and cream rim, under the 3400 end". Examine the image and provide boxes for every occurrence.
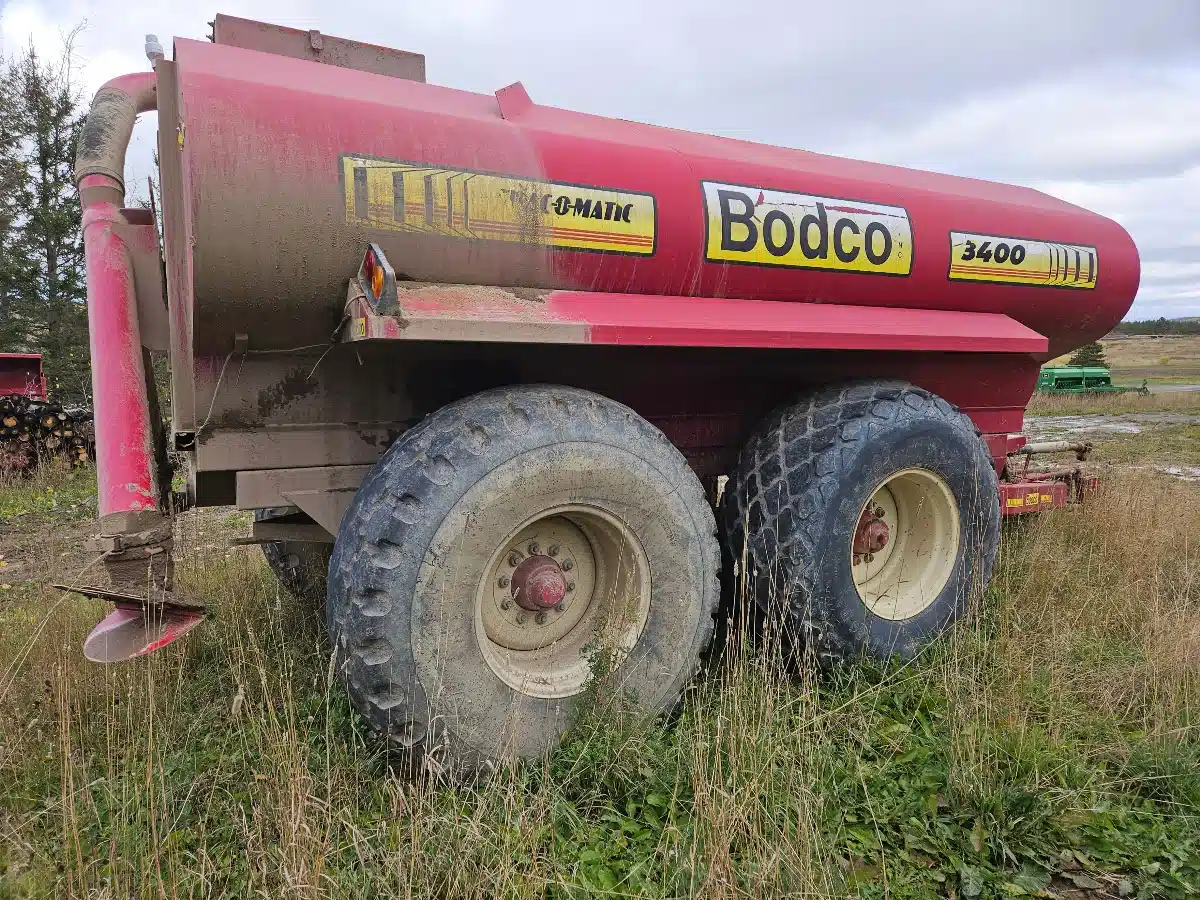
[720,380,1000,661]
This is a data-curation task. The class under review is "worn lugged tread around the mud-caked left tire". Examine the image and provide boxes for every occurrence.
[329,385,720,770]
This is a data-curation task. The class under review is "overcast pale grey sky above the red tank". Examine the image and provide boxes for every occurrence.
[0,0,1200,318]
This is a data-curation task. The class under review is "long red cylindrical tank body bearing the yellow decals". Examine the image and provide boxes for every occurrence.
[169,40,1139,354]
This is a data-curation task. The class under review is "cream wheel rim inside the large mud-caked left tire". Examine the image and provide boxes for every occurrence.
[475,505,650,698]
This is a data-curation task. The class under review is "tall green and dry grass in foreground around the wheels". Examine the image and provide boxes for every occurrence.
[0,475,1200,899]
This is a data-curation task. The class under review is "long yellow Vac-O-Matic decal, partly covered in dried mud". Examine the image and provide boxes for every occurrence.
[342,156,656,256]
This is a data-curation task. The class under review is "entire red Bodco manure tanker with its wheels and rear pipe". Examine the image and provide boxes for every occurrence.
[72,16,1140,769]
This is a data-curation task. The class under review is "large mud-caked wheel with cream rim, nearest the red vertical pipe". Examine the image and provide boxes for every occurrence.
[329,385,720,775]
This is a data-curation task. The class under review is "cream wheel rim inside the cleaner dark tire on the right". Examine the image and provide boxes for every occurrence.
[850,469,961,620]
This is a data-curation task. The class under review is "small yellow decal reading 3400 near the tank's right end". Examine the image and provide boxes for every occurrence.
[949,232,1100,289]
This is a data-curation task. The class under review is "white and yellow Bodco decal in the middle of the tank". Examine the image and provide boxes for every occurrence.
[702,181,912,275]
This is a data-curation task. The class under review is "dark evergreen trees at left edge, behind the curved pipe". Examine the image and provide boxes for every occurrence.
[0,34,91,403]
